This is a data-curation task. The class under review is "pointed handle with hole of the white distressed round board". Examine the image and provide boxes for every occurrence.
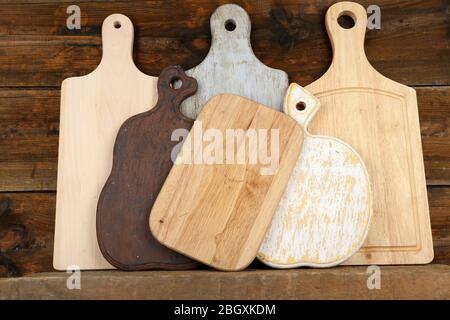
[283,83,320,131]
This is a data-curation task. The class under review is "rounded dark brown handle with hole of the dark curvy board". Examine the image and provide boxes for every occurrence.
[157,66,198,118]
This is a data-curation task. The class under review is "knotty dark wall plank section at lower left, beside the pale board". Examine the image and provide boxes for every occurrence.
[0,193,56,277]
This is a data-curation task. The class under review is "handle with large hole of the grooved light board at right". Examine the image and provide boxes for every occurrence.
[325,1,369,73]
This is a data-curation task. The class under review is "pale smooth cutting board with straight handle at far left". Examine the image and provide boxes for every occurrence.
[53,14,157,270]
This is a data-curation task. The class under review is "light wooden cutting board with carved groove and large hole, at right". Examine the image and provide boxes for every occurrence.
[306,2,433,265]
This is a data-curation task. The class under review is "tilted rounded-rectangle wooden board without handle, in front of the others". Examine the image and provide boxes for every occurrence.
[150,94,303,270]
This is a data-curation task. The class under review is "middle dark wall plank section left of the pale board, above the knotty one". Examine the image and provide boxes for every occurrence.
[0,89,60,191]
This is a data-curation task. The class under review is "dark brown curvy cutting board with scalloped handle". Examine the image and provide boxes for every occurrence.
[97,66,198,270]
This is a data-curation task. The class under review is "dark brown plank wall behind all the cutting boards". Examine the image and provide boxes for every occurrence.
[0,0,450,277]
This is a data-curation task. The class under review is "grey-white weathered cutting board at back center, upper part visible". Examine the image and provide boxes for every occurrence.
[181,4,289,119]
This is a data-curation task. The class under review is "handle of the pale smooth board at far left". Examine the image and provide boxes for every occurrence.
[100,14,136,70]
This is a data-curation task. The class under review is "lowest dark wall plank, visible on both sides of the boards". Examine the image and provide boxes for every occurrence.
[0,187,450,278]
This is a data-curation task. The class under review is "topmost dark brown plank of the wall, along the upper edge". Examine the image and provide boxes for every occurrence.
[0,0,447,37]
